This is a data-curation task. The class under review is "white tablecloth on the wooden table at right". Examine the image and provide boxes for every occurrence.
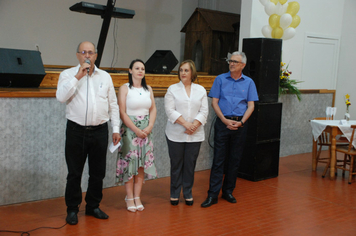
[310,120,356,147]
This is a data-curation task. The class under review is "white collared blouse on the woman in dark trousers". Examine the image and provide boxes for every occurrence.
[164,82,209,142]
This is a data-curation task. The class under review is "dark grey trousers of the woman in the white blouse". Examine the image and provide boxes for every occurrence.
[166,137,201,199]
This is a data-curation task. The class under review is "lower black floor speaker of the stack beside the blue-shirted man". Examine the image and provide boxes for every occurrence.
[238,102,282,181]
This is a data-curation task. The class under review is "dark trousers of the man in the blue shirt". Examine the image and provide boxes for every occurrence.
[208,117,248,198]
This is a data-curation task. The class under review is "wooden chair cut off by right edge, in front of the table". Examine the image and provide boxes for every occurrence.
[335,125,356,184]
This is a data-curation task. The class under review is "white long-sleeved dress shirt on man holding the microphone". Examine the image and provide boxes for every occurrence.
[56,65,120,133]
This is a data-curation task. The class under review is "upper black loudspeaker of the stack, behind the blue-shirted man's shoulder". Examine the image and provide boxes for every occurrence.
[242,38,282,102]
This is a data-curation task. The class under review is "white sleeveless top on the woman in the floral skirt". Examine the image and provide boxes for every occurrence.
[125,83,152,116]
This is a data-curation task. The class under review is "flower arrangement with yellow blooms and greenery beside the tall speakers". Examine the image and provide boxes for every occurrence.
[278,62,302,101]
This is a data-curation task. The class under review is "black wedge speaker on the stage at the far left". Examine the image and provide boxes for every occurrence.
[0,48,46,88]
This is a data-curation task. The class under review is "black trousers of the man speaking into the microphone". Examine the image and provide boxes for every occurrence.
[65,120,108,212]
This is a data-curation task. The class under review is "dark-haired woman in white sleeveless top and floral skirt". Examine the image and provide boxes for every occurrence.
[116,59,157,212]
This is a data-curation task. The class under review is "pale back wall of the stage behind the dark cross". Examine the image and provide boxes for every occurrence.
[0,0,182,68]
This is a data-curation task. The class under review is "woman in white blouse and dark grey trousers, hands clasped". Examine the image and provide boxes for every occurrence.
[164,60,208,206]
